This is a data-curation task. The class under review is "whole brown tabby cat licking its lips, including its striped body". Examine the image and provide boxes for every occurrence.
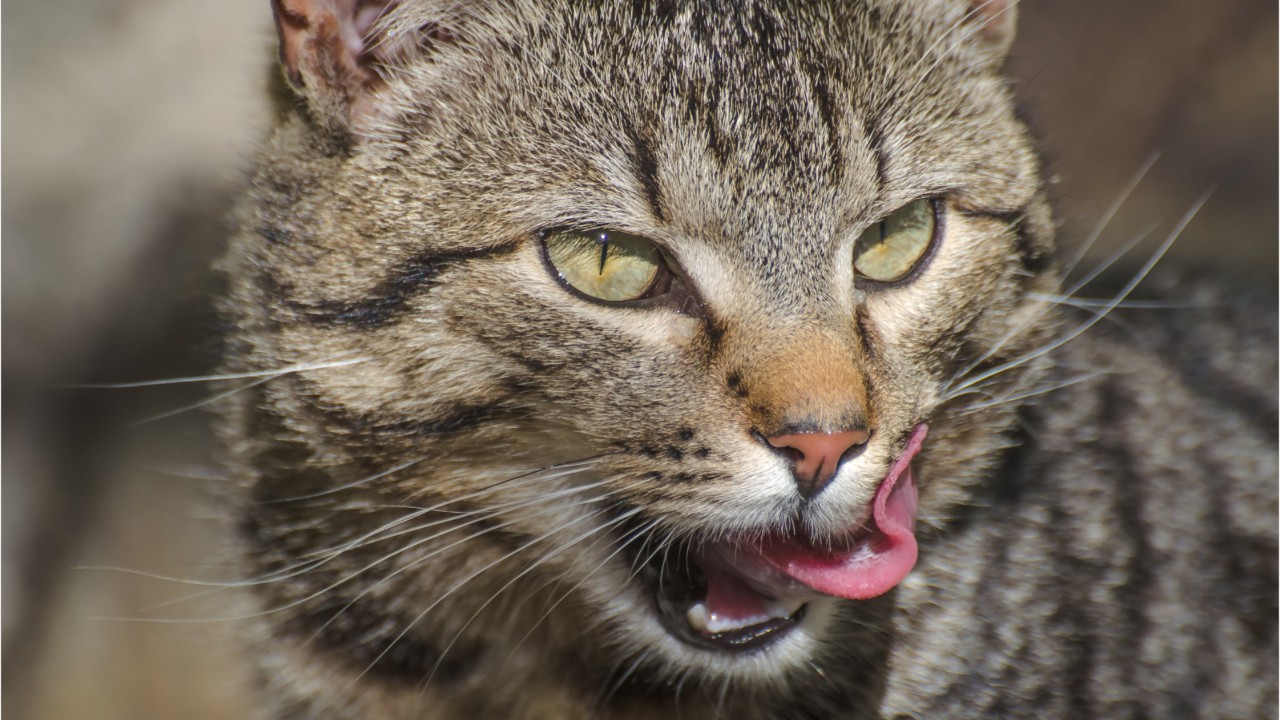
[219,0,1276,719]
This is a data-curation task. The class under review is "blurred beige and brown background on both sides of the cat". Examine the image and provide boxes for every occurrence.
[0,0,1277,720]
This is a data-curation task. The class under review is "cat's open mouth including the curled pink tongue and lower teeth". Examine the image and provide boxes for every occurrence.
[645,424,927,651]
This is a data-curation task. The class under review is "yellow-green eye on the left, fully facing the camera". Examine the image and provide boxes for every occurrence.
[544,231,663,302]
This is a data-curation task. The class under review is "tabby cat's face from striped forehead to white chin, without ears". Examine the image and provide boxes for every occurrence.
[227,4,1052,682]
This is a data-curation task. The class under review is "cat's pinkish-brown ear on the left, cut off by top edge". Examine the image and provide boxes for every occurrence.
[271,0,397,135]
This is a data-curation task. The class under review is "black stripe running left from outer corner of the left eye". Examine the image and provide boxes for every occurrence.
[284,242,518,329]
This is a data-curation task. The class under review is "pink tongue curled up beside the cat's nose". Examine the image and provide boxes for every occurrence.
[760,424,928,600]
